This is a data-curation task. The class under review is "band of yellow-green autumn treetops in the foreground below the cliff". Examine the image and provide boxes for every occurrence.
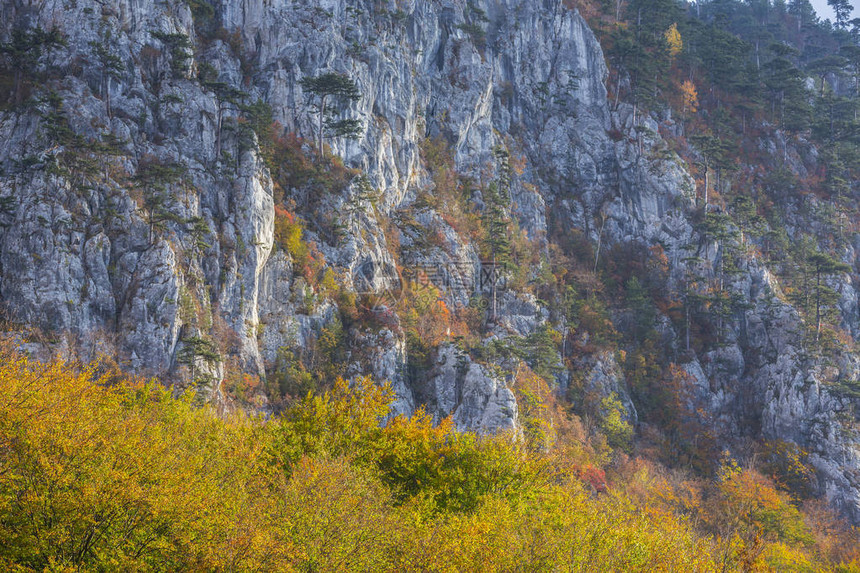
[0,352,860,571]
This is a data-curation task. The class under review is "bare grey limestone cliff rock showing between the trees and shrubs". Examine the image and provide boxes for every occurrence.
[5,0,860,523]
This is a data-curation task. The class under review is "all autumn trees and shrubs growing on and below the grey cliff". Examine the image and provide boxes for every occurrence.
[0,0,860,571]
